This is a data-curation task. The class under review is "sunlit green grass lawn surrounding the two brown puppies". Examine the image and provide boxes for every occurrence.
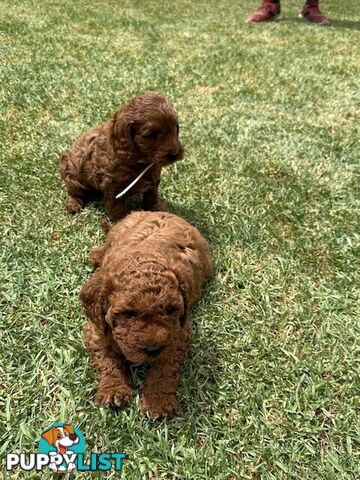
[0,0,360,480]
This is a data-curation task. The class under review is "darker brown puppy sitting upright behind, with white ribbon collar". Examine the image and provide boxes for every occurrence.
[60,92,184,220]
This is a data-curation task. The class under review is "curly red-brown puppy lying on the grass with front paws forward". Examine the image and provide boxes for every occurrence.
[80,212,213,419]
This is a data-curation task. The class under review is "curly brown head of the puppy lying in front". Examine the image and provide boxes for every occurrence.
[80,255,189,363]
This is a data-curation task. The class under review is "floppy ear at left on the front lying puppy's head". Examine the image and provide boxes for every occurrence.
[79,269,110,332]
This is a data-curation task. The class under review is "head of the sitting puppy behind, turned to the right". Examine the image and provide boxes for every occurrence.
[113,92,184,166]
